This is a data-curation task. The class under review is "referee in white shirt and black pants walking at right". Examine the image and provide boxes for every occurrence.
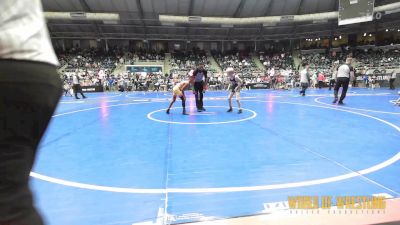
[333,58,354,105]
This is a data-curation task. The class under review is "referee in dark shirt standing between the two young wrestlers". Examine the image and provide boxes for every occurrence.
[193,63,208,112]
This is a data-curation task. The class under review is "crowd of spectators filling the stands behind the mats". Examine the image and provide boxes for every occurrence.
[58,44,400,94]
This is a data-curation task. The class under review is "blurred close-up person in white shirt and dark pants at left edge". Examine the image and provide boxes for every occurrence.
[0,0,62,225]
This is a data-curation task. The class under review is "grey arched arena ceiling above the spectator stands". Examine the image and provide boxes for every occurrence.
[42,0,400,40]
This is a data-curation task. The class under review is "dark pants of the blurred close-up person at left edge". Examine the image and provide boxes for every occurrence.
[0,60,62,225]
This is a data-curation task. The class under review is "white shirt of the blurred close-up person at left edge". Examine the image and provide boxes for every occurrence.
[0,0,58,65]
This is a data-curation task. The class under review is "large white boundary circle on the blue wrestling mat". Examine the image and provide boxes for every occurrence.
[30,100,400,194]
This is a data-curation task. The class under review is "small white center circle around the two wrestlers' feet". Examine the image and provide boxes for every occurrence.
[147,106,257,125]
